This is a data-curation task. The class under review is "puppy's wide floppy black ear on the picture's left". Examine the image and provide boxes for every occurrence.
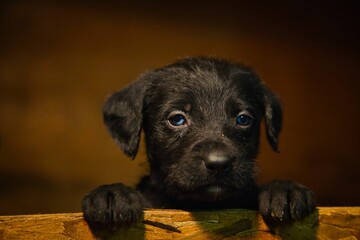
[102,74,146,159]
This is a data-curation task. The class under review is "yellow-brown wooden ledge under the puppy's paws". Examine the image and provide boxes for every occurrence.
[0,207,360,240]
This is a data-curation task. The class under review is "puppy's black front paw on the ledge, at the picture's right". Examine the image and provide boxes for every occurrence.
[259,180,315,222]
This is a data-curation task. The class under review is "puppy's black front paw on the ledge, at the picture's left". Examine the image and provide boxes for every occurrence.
[82,183,143,229]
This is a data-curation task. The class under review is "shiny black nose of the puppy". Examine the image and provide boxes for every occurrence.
[204,152,234,172]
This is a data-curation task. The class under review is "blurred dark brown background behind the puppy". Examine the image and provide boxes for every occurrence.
[0,0,360,214]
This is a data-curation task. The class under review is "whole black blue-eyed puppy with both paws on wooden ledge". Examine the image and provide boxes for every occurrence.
[82,57,315,228]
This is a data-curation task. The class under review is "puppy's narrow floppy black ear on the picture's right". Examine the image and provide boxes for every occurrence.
[263,86,282,152]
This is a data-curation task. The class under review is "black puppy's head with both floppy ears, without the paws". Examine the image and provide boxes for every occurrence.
[103,57,282,201]
